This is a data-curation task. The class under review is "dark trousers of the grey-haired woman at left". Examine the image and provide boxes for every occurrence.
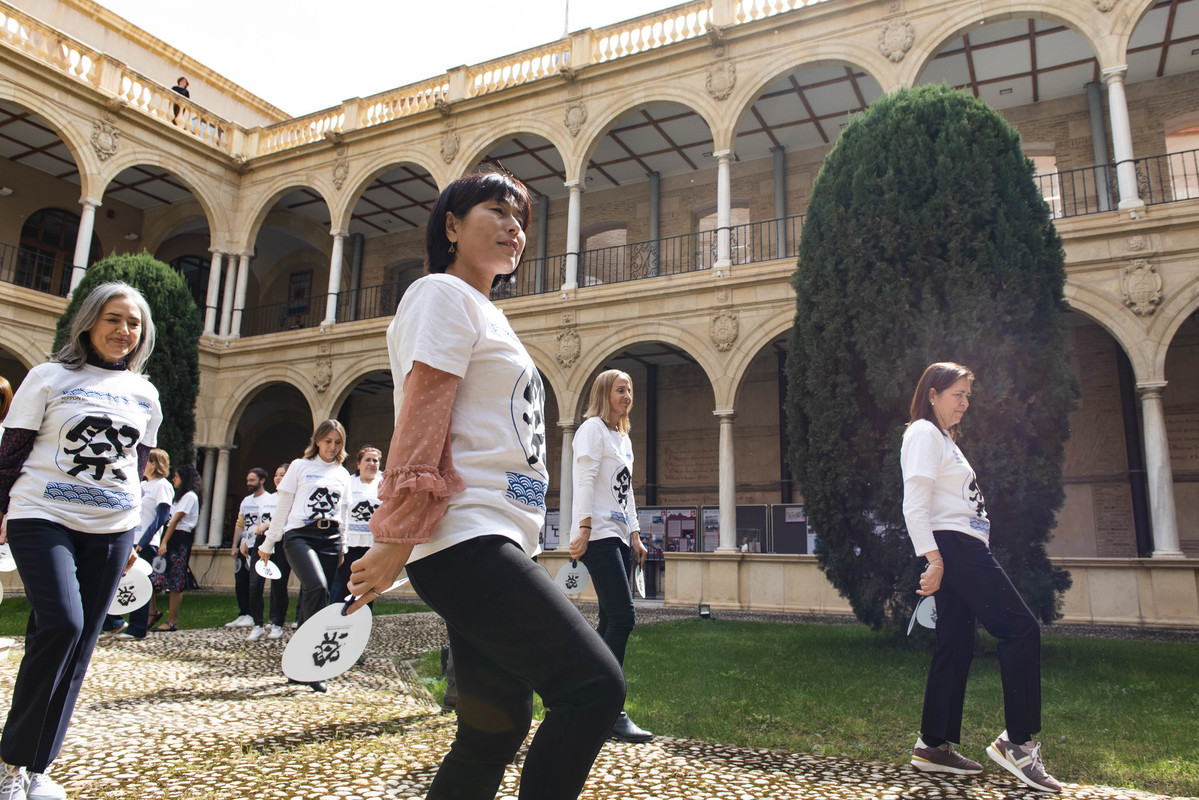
[0,519,134,772]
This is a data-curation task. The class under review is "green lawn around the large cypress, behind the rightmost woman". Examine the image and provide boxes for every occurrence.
[421,619,1199,795]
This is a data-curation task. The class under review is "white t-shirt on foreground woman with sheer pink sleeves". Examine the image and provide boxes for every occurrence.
[387,273,549,561]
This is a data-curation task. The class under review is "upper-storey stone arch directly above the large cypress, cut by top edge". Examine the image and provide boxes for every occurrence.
[898,0,1116,86]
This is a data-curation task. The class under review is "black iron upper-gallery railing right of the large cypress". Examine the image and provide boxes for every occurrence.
[1036,150,1199,219]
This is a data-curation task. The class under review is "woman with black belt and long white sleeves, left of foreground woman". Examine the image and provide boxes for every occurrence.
[258,420,350,692]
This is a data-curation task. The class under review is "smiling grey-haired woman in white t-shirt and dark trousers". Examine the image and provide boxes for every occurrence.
[0,282,162,796]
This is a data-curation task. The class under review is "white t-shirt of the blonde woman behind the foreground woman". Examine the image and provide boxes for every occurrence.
[571,416,641,545]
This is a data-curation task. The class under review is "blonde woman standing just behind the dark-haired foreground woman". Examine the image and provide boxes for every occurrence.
[571,369,653,742]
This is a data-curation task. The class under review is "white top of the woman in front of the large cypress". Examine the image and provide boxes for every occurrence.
[899,420,990,554]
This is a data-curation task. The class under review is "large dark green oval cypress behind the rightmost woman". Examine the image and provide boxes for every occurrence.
[787,86,1078,628]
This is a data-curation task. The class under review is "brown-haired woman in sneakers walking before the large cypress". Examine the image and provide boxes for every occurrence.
[899,362,1061,792]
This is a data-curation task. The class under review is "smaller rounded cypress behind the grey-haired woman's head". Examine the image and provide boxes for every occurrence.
[54,252,203,472]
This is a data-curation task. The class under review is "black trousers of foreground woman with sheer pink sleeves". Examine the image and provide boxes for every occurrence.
[408,536,625,800]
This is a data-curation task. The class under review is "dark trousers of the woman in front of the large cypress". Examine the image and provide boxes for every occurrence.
[920,530,1041,744]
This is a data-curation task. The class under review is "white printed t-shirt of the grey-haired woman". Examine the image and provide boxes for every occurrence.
[5,362,162,534]
